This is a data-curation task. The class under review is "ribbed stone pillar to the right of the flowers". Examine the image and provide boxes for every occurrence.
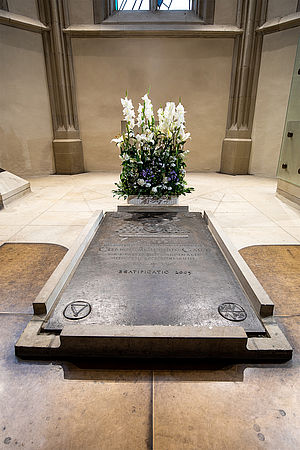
[221,0,267,175]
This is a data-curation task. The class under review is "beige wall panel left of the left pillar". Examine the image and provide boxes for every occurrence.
[0,25,53,175]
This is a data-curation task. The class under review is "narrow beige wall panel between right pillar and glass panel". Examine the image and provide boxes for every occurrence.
[249,28,299,176]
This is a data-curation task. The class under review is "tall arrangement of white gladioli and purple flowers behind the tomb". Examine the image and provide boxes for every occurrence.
[112,93,194,198]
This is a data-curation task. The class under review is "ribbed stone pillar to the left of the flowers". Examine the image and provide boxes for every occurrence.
[38,0,84,175]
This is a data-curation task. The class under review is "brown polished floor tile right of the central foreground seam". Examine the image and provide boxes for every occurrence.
[153,317,300,450]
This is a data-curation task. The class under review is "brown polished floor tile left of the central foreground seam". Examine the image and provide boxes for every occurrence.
[0,314,152,450]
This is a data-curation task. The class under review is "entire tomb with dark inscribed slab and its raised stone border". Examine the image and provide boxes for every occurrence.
[16,207,292,359]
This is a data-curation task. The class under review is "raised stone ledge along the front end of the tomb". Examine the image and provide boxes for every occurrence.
[15,318,293,362]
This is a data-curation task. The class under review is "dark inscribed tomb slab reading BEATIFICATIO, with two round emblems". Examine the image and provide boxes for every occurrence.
[44,212,265,334]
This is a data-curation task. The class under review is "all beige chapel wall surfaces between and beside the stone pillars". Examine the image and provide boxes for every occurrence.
[0,0,299,176]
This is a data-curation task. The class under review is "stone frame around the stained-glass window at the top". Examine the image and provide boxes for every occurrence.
[93,0,215,25]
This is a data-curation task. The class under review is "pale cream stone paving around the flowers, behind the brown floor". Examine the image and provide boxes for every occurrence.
[0,172,300,248]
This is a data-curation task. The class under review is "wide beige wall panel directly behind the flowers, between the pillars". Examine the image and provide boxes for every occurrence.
[72,38,233,171]
